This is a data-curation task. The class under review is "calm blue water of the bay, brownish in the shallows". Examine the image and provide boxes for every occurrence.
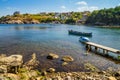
[0,24,120,71]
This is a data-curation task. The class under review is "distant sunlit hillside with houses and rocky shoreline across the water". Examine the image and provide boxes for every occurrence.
[0,11,90,24]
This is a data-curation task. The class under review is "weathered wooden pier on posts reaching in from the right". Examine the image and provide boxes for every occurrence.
[85,42,120,55]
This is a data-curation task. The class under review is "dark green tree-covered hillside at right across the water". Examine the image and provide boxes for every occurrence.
[86,6,120,26]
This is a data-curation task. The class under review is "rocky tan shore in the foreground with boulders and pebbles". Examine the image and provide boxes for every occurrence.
[0,53,120,80]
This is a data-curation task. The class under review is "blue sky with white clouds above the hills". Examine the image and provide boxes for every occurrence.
[0,0,120,16]
